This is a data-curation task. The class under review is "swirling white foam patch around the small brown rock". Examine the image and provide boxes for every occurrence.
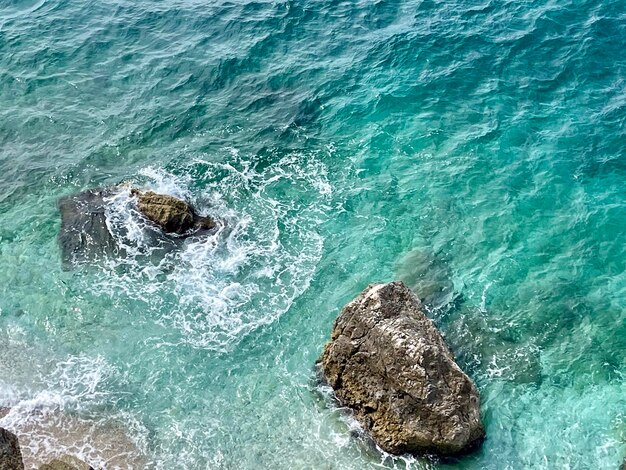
[87,150,332,351]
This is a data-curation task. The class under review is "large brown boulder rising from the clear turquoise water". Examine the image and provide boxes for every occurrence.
[318,282,485,456]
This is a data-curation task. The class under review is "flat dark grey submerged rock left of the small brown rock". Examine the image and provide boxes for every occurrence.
[58,188,119,263]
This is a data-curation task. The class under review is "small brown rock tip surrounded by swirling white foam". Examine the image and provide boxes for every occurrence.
[131,189,216,235]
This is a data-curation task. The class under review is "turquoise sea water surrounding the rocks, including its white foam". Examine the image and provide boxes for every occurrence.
[0,0,626,470]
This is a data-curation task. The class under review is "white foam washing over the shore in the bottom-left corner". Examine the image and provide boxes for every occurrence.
[0,356,146,469]
